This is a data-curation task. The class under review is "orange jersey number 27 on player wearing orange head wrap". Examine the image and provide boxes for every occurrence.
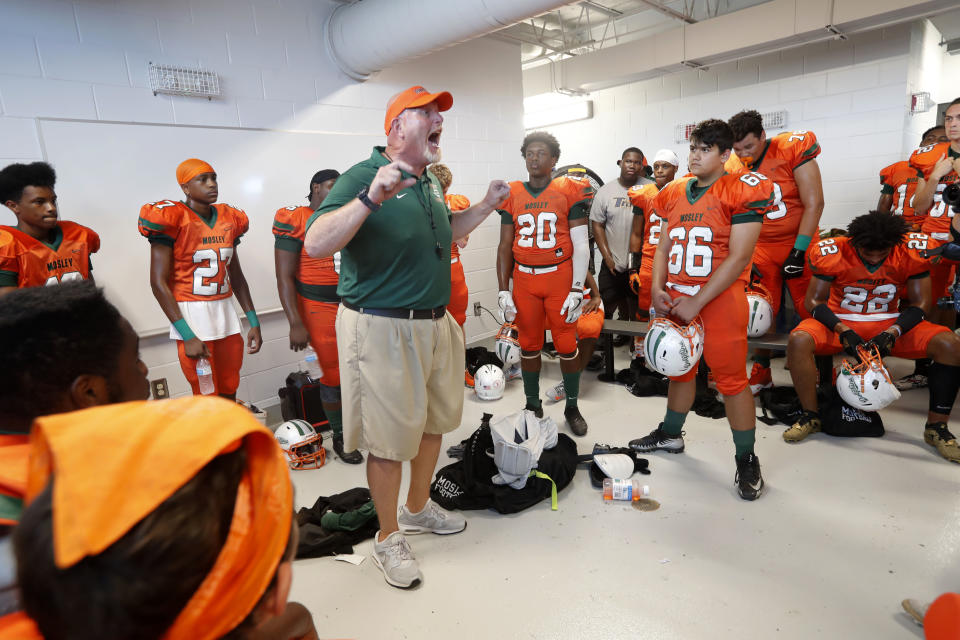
[138,200,250,302]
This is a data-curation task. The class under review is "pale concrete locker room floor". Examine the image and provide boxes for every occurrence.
[291,350,960,639]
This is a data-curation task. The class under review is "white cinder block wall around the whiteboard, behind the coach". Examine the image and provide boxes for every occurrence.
[0,0,523,404]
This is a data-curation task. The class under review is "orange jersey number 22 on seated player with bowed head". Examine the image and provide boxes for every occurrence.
[807,233,930,322]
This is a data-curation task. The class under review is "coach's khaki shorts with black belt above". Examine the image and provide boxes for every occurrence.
[337,305,464,460]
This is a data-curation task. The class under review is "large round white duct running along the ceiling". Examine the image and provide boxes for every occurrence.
[324,0,570,81]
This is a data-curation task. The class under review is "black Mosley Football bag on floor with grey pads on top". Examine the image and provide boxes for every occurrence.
[430,414,577,513]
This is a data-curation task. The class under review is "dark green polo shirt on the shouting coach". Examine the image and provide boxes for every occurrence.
[307,147,453,309]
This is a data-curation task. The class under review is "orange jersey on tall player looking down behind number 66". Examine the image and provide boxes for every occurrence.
[744,131,820,246]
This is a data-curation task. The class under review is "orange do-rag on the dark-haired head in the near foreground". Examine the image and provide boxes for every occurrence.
[21,396,293,640]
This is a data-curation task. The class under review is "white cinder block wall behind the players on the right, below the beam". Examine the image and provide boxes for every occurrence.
[536,21,960,232]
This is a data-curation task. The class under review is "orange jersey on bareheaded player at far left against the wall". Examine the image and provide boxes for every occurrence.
[0,222,100,287]
